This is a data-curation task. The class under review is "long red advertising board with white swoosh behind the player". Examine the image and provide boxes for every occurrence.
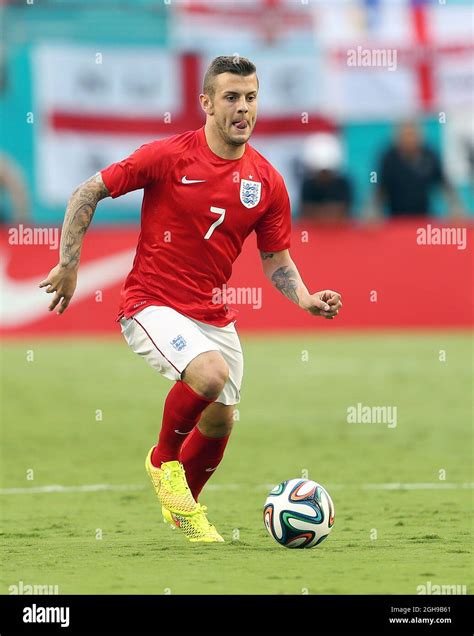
[0,220,473,336]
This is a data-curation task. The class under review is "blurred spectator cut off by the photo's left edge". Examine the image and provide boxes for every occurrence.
[0,153,30,224]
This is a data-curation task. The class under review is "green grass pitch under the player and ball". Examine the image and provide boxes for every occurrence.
[0,332,472,594]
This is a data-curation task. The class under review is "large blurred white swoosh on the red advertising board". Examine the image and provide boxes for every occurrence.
[0,249,135,328]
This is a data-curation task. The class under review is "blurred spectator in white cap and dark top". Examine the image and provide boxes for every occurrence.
[300,133,352,223]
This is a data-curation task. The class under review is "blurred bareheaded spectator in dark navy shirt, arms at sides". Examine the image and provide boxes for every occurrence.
[369,122,464,218]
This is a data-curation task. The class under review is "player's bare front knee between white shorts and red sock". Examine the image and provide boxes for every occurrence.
[182,351,229,400]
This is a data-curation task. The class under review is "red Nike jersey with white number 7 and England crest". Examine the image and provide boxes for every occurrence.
[101,127,291,327]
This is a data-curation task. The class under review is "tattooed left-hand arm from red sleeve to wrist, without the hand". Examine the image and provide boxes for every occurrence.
[59,172,109,269]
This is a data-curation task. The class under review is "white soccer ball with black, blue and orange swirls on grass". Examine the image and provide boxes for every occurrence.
[263,479,334,548]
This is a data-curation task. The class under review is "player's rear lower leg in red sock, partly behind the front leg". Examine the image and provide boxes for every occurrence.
[179,402,235,501]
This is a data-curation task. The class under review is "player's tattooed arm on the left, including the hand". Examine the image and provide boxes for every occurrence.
[39,172,109,314]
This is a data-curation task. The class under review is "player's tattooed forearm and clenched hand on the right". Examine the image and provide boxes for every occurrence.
[260,250,342,320]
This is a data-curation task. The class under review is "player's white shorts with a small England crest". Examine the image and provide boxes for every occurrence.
[120,305,244,406]
